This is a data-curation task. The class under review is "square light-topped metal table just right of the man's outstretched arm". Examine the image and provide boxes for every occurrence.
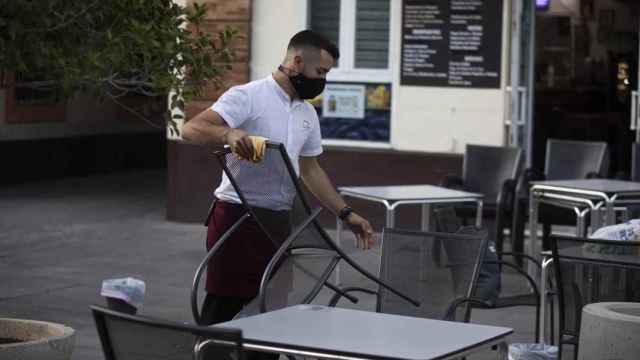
[336,185,484,283]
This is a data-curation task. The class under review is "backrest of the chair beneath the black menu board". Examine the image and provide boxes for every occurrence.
[462,145,522,202]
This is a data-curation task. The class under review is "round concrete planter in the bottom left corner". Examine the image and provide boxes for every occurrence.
[0,318,75,360]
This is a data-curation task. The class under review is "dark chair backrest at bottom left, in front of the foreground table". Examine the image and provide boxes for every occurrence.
[91,306,244,360]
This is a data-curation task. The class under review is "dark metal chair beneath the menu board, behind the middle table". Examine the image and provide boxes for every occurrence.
[440,145,523,252]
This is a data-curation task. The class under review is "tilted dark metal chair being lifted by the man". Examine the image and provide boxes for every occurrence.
[191,143,419,323]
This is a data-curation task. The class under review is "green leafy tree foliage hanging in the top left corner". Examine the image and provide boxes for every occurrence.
[0,0,237,132]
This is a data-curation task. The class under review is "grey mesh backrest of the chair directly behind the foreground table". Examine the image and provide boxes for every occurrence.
[377,228,486,321]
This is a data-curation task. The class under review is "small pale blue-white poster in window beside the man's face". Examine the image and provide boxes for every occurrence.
[322,84,365,119]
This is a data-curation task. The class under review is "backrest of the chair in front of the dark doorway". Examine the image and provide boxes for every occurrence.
[544,139,609,180]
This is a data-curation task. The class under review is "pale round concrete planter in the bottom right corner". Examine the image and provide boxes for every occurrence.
[578,302,640,360]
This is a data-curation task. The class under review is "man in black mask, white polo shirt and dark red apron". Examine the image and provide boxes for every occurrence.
[182,30,373,323]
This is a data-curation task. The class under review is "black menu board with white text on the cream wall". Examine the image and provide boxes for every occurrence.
[400,0,503,88]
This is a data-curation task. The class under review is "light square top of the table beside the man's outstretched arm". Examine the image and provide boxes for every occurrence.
[338,185,484,201]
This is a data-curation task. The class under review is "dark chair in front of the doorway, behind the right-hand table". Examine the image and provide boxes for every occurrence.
[511,139,609,252]
